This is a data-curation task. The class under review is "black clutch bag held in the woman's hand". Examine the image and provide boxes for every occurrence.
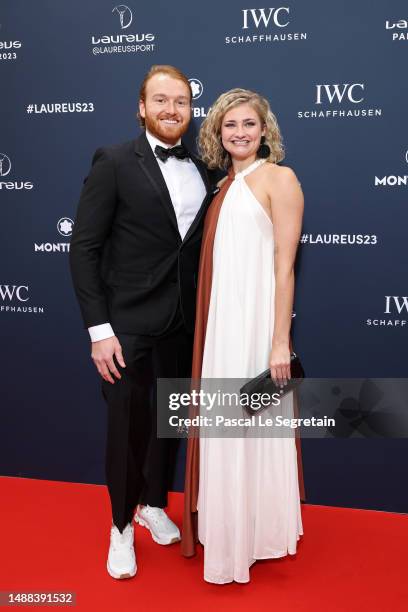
[239,353,305,415]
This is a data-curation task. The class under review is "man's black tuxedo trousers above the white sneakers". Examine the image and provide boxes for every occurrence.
[102,326,193,531]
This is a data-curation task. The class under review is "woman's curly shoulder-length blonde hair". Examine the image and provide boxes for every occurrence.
[198,88,285,169]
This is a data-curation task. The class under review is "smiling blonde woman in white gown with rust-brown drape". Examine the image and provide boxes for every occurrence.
[183,89,303,584]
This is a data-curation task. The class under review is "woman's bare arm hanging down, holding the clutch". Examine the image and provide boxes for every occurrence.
[269,166,304,384]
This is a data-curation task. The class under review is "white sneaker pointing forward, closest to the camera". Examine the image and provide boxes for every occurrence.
[106,523,137,579]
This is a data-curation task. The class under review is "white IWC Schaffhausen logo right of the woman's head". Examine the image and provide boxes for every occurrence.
[297,83,382,119]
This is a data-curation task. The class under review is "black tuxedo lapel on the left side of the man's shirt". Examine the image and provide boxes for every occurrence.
[135,133,180,235]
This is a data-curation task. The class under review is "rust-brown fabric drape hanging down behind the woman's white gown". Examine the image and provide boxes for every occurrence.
[181,170,305,557]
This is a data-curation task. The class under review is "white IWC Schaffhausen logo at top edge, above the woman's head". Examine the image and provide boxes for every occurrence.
[225,6,307,45]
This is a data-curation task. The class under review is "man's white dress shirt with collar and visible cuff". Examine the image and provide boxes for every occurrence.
[88,130,206,342]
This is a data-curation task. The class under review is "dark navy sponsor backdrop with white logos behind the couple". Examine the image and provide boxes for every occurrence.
[0,0,408,512]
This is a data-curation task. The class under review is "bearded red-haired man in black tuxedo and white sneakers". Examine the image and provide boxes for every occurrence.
[70,66,211,578]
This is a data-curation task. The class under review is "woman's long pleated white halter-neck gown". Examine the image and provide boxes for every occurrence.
[197,160,303,584]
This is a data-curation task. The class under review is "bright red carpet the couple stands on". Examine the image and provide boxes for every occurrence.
[0,478,408,612]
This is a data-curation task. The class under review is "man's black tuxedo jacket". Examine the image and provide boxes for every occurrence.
[70,133,212,336]
